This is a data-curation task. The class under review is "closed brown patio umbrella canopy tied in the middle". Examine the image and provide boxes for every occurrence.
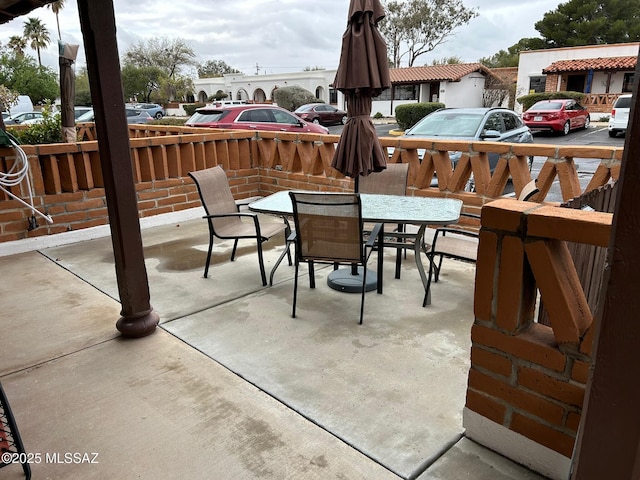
[331,0,391,178]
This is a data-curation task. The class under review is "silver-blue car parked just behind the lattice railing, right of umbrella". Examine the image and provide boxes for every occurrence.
[400,108,533,172]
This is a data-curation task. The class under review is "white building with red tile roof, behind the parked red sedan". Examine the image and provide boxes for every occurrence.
[515,42,640,113]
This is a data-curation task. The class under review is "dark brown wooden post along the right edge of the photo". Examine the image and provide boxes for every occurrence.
[572,47,640,480]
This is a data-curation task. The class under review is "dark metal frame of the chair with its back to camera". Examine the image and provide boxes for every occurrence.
[288,192,382,325]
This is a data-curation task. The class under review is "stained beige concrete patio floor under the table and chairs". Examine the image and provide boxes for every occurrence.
[0,210,542,480]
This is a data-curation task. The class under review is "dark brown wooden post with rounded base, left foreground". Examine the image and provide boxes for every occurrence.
[78,0,159,337]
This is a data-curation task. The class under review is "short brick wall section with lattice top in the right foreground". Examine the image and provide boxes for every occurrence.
[466,200,612,476]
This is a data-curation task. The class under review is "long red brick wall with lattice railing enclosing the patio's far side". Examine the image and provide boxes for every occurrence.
[0,125,622,242]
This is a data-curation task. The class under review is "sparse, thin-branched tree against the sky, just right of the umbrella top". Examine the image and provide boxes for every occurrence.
[380,0,478,67]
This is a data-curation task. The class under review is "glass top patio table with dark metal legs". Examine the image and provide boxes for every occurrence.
[249,190,462,305]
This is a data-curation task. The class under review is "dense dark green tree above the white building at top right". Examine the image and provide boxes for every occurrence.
[535,0,640,48]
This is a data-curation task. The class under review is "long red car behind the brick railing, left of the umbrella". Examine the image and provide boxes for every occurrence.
[185,104,329,134]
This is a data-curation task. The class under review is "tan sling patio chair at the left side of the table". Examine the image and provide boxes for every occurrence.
[189,165,291,286]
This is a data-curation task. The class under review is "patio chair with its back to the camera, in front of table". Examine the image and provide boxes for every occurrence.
[289,192,382,324]
